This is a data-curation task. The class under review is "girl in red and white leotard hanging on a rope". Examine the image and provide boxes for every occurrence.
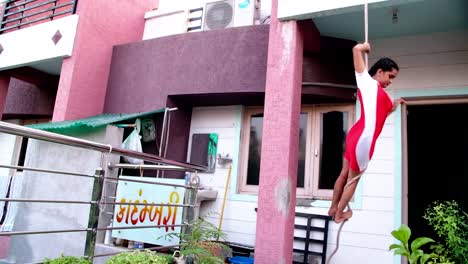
[328,42,405,223]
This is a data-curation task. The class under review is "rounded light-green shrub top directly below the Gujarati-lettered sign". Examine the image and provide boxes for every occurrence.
[106,250,174,264]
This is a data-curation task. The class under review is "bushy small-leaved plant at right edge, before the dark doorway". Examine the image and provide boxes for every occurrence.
[424,201,468,264]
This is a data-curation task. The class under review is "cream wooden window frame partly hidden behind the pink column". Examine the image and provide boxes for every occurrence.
[237,103,356,200]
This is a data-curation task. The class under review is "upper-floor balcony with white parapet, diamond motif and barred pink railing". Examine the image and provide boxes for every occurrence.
[0,0,78,75]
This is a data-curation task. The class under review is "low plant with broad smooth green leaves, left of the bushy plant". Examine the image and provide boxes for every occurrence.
[389,224,438,264]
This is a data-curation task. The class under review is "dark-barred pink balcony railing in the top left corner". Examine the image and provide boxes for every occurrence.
[0,0,78,34]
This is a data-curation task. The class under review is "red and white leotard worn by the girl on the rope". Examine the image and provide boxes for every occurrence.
[344,70,393,172]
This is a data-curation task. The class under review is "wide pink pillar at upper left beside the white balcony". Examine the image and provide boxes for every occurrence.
[52,0,158,121]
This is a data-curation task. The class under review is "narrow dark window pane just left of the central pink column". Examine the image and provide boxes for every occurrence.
[247,113,263,185]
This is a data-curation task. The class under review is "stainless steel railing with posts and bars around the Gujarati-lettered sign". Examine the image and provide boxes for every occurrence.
[0,122,206,260]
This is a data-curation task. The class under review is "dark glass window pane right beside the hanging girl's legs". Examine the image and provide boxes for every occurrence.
[319,111,349,189]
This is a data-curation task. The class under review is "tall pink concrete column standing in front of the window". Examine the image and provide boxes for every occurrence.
[255,0,303,264]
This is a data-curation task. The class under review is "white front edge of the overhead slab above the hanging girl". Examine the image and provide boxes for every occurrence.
[278,0,394,20]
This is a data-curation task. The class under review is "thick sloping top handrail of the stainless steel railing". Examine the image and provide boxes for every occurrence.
[0,121,207,171]
